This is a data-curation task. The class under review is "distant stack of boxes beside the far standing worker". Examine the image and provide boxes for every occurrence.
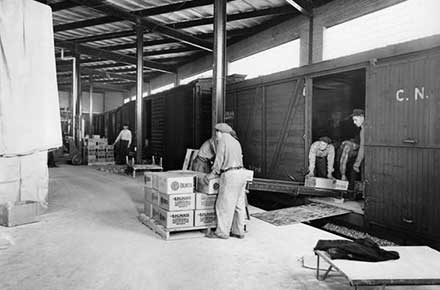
[85,135,115,165]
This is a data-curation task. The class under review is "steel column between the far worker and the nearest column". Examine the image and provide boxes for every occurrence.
[136,26,144,163]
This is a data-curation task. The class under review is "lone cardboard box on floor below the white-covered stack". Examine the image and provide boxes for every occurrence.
[0,201,39,227]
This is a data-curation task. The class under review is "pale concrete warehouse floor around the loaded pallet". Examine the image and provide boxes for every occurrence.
[0,165,439,290]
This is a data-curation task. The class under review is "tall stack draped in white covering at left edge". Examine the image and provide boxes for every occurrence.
[0,0,62,208]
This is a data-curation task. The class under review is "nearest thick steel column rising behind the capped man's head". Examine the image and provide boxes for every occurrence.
[212,0,227,133]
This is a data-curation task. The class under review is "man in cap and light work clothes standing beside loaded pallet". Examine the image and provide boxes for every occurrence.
[205,123,247,239]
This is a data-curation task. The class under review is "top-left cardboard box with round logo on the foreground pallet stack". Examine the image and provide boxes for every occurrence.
[153,172,194,194]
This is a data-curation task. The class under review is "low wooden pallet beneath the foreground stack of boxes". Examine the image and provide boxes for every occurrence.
[138,213,212,241]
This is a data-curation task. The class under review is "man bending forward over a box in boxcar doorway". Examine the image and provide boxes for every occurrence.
[307,137,335,179]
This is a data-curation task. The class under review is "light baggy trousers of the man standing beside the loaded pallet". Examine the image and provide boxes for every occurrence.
[215,170,246,236]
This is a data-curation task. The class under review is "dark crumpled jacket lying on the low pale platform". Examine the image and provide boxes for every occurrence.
[315,238,399,262]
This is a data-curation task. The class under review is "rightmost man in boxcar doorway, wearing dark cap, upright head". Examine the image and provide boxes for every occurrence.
[339,109,365,184]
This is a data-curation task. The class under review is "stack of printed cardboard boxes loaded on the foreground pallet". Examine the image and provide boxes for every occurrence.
[144,171,218,230]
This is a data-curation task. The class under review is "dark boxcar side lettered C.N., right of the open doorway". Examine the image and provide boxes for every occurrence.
[365,49,440,241]
